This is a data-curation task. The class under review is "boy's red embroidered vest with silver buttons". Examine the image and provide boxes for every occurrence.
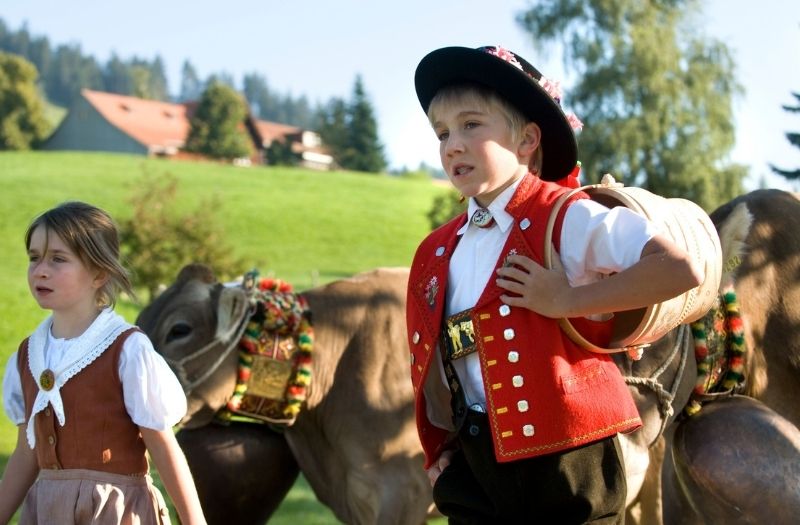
[406,175,641,468]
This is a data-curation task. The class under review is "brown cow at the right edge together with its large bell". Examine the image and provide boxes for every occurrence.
[628,190,800,525]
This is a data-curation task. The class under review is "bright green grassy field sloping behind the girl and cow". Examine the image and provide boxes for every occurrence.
[0,152,446,523]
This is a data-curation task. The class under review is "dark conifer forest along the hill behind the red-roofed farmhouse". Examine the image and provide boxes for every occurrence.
[0,19,387,172]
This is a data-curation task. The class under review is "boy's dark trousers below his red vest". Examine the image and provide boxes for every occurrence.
[433,410,626,525]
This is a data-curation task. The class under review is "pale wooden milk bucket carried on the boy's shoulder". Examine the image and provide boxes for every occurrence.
[544,174,722,353]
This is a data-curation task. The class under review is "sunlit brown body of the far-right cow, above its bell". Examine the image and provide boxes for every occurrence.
[711,190,800,426]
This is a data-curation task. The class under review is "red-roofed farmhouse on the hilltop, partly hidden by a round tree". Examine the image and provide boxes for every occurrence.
[42,89,333,170]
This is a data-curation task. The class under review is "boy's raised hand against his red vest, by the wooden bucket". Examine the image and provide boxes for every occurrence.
[496,255,571,318]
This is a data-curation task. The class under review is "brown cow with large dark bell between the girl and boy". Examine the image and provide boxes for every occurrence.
[137,266,432,525]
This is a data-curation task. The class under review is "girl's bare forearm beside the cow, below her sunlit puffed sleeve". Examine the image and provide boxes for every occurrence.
[139,427,206,525]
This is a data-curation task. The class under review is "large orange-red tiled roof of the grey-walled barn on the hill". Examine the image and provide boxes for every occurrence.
[81,89,189,148]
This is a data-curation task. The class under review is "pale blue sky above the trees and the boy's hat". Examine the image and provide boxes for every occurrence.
[0,0,800,189]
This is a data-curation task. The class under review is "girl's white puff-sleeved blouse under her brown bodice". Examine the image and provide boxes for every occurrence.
[3,324,186,430]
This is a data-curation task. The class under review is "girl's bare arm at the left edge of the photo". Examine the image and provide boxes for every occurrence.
[0,423,39,523]
